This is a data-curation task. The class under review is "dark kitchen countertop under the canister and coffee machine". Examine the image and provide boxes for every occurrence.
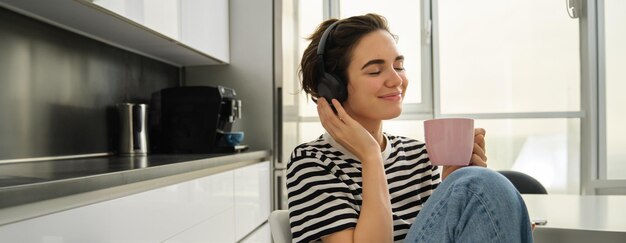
[0,151,270,225]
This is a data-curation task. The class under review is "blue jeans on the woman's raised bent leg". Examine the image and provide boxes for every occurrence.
[404,166,533,243]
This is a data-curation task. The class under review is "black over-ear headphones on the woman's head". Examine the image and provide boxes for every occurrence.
[317,20,348,103]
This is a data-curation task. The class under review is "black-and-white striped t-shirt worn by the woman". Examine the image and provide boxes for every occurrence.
[287,133,441,242]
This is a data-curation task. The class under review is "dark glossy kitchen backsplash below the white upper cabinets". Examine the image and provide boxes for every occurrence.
[0,8,179,161]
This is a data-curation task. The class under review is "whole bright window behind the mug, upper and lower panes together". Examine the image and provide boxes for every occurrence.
[434,0,582,193]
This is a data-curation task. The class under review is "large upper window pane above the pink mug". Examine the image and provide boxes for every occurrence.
[437,0,580,114]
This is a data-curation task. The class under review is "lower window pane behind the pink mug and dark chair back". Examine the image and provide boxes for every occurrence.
[475,118,580,194]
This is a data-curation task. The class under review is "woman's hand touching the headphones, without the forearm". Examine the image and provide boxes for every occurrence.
[317,97,380,161]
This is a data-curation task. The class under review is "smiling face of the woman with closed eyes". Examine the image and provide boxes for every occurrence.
[343,30,408,120]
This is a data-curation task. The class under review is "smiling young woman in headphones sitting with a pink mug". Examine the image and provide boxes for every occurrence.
[287,14,532,243]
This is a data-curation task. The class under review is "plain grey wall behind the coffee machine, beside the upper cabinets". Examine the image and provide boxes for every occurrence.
[184,0,274,152]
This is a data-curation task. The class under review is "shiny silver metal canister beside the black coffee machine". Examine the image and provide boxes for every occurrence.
[117,103,148,156]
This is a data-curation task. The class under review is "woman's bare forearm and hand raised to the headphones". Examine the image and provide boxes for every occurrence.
[317,98,393,243]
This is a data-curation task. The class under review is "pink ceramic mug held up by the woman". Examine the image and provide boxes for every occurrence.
[424,118,474,166]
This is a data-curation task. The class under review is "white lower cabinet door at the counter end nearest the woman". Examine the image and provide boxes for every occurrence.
[235,161,271,241]
